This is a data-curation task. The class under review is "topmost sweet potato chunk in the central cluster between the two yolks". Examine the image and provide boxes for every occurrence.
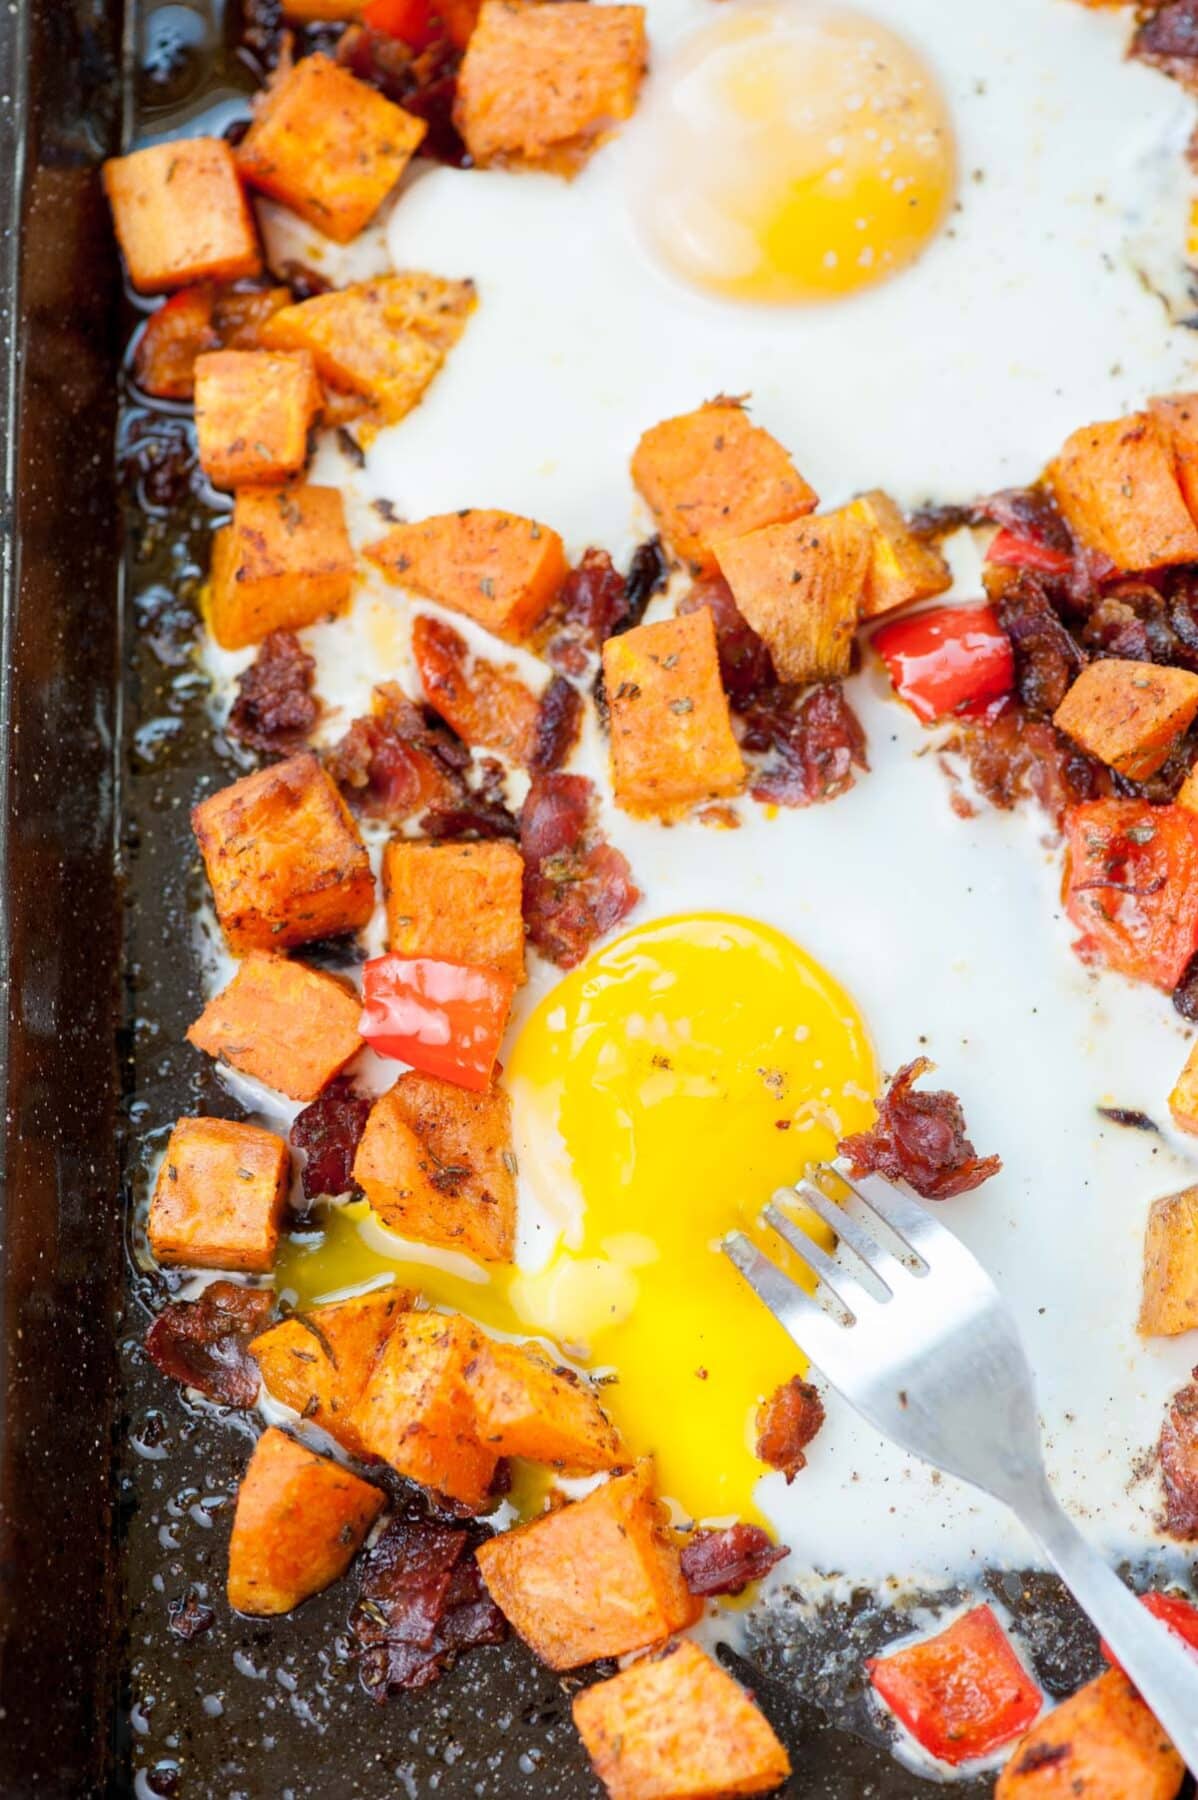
[631,400,818,574]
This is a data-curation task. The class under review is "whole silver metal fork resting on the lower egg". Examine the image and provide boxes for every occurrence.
[723,1163,1198,1775]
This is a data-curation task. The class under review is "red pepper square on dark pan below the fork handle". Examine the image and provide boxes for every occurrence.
[865,1606,1043,1768]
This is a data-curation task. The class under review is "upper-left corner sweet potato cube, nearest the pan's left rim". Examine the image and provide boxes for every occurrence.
[104,137,263,293]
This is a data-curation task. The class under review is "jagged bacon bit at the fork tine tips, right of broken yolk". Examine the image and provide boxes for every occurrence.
[836,1057,1002,1201]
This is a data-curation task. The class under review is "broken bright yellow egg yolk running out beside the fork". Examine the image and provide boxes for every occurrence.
[279,914,878,1521]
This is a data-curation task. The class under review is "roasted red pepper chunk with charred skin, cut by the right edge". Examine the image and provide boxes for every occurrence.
[1061,799,1198,994]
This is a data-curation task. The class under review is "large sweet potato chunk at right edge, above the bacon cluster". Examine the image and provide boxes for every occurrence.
[1045,412,1198,571]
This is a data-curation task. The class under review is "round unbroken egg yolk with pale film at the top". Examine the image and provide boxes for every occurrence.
[633,4,955,302]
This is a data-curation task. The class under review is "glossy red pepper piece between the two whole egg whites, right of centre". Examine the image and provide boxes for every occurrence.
[874,607,1015,725]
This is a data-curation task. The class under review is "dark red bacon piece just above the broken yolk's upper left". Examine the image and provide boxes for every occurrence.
[520,774,640,968]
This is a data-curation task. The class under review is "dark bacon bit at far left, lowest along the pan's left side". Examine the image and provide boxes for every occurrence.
[146,1282,275,1406]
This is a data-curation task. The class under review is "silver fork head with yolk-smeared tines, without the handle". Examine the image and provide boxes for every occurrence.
[723,1163,1043,1501]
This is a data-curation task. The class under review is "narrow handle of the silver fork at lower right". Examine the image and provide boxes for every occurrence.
[1015,1481,1198,1775]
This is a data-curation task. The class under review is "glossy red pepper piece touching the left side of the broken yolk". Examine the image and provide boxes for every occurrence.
[358,956,516,1093]
